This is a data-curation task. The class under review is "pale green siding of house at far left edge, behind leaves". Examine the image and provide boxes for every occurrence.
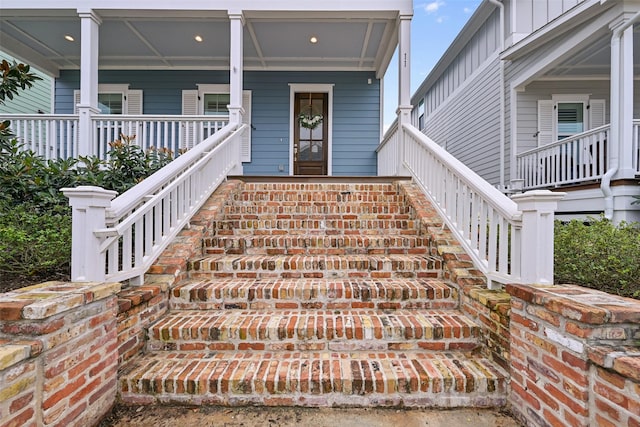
[0,52,53,114]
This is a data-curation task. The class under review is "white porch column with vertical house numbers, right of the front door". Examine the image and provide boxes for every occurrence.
[396,15,412,175]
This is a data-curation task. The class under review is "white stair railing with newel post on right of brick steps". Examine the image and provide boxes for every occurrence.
[378,124,564,287]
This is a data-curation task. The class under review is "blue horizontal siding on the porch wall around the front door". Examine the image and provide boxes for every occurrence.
[55,70,380,175]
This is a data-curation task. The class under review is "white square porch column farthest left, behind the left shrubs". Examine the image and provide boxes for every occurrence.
[77,9,102,156]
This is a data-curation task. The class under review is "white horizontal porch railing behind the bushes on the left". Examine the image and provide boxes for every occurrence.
[0,114,229,160]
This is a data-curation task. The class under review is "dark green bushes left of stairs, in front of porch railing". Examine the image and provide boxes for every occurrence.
[0,136,172,285]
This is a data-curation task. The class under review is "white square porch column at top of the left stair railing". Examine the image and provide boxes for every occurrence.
[228,11,244,124]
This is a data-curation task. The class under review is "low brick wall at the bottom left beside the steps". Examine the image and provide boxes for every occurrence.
[0,282,120,427]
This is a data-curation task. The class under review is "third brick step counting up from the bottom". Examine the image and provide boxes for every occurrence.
[169,279,458,310]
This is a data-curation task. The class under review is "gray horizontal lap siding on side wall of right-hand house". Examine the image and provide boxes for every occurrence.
[424,59,500,185]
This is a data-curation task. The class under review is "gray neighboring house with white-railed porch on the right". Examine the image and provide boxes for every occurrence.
[412,0,640,220]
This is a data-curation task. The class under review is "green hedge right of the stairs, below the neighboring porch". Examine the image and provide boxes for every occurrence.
[555,218,640,298]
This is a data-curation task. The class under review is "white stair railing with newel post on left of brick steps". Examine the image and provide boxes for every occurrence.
[62,124,246,283]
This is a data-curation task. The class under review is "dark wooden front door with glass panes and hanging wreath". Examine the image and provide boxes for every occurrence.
[293,92,329,175]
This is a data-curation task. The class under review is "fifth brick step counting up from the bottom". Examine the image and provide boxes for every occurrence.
[203,233,430,255]
